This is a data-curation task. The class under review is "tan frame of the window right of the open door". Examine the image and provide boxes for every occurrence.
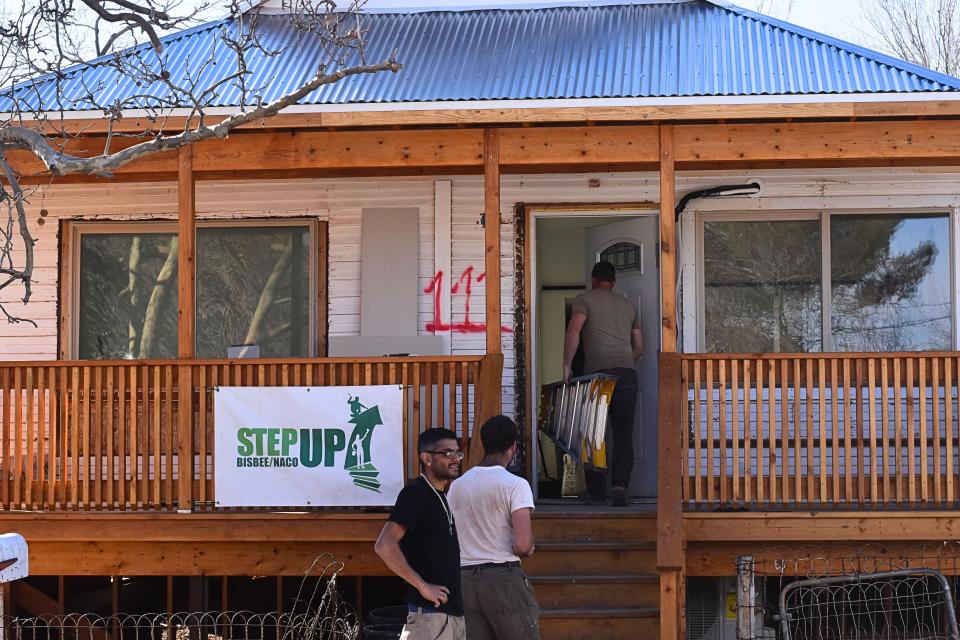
[695,207,960,353]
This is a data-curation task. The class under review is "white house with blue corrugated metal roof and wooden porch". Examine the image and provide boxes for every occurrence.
[0,0,960,639]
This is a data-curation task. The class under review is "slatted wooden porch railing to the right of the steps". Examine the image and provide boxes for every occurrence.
[660,352,960,509]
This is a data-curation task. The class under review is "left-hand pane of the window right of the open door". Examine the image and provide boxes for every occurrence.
[703,220,822,353]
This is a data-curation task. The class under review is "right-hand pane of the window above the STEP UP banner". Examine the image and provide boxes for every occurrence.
[197,226,311,358]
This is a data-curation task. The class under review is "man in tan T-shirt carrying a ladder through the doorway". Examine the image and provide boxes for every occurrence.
[563,261,643,507]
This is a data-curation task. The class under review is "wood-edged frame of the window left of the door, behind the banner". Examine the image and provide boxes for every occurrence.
[66,217,328,360]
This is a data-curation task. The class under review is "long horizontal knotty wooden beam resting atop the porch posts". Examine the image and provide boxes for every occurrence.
[11,119,960,180]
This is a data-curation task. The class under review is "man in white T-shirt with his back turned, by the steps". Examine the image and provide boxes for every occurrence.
[447,416,540,640]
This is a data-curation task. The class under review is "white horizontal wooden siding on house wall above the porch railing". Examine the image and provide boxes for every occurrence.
[0,168,960,420]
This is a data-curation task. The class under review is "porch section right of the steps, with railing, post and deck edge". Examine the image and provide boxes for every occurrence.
[657,352,960,637]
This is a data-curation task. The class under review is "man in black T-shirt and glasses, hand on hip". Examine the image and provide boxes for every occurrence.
[374,429,466,640]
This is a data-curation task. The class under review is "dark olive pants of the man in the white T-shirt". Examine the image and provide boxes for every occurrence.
[460,566,540,640]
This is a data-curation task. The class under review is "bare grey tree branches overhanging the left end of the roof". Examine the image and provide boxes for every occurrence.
[0,0,401,322]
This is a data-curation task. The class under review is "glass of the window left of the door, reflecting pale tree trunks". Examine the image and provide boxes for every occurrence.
[74,221,317,359]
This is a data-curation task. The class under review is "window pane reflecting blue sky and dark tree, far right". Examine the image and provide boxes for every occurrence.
[830,214,952,351]
